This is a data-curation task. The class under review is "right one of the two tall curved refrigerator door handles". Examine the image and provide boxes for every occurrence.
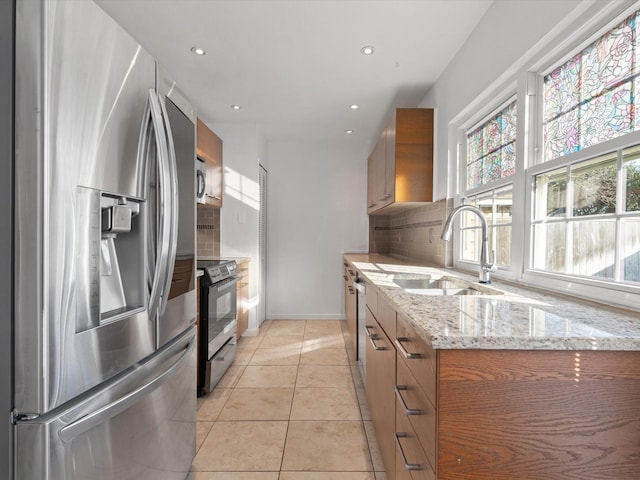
[159,97,179,315]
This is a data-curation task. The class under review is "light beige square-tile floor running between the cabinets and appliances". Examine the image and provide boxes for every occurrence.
[188,320,385,480]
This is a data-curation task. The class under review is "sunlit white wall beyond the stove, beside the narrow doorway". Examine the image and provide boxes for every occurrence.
[214,124,266,333]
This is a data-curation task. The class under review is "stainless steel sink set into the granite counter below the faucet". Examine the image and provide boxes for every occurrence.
[390,275,502,296]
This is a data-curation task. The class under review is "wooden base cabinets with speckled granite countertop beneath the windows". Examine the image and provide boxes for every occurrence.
[345,254,640,480]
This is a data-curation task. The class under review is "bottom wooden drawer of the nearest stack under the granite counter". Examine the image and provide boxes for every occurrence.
[395,401,436,480]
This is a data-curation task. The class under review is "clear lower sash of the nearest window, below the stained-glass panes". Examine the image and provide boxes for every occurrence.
[532,146,640,282]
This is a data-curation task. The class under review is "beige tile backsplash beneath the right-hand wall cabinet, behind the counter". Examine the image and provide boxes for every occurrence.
[369,199,453,267]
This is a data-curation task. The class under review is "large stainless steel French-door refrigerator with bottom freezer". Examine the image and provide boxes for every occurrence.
[7,0,196,480]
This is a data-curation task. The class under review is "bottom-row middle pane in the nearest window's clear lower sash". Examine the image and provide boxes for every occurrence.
[566,220,616,278]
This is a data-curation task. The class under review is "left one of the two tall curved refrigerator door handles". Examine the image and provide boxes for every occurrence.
[149,89,173,321]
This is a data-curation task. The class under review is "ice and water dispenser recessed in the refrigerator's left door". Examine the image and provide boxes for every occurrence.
[75,187,145,331]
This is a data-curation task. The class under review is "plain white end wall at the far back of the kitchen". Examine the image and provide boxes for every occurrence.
[267,142,368,319]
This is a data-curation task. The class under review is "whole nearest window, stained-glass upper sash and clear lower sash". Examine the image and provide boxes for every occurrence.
[531,8,640,284]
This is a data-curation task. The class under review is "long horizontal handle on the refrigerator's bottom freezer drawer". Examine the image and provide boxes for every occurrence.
[59,336,195,443]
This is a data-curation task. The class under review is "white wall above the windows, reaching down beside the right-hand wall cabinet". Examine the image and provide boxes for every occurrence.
[419,0,594,200]
